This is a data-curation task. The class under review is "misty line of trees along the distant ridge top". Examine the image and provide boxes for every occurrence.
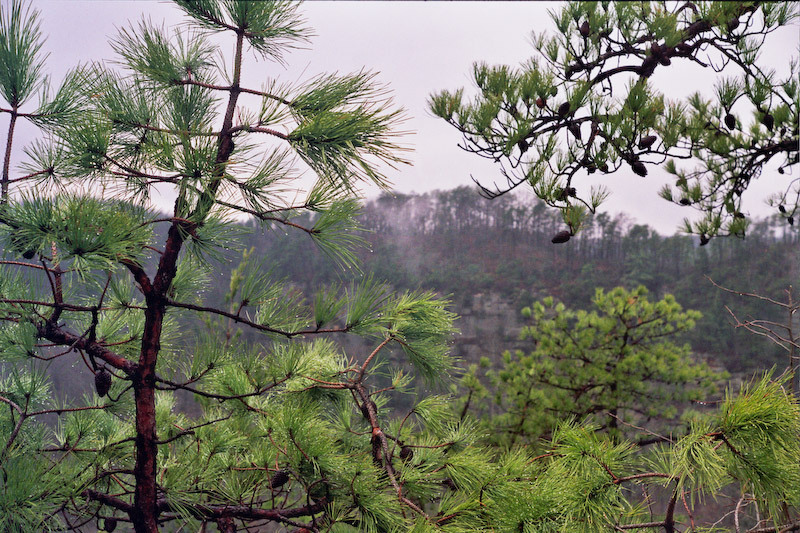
[228,187,800,371]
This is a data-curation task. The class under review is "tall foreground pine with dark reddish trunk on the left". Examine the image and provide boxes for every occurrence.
[0,1,469,532]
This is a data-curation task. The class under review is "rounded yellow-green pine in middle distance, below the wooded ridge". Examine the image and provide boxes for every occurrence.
[467,286,725,445]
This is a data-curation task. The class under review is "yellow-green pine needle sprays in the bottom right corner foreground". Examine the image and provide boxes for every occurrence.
[496,376,800,531]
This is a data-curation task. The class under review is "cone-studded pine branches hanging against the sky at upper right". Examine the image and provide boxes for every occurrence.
[430,2,800,244]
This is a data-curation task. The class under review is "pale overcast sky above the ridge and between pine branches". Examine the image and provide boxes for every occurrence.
[7,0,800,234]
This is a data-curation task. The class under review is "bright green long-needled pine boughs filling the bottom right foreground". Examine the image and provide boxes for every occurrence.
[482,374,800,533]
